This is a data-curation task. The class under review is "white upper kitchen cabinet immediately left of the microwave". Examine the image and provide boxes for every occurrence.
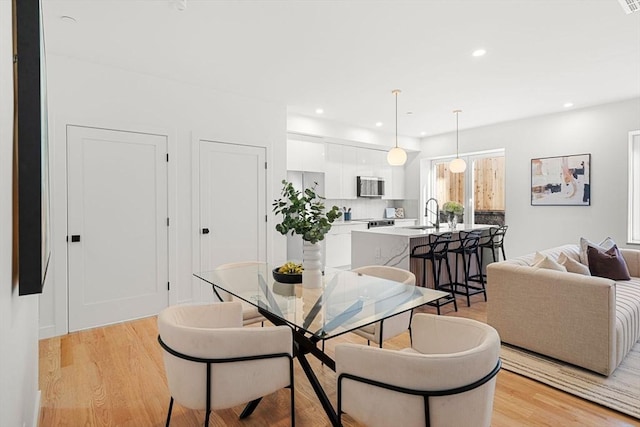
[325,144,357,200]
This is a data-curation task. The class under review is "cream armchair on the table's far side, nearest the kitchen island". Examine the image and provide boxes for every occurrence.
[353,265,416,348]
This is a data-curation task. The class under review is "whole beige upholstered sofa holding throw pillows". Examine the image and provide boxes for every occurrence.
[487,245,640,375]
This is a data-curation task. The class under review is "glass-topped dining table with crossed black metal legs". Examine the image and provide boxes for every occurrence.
[194,262,448,425]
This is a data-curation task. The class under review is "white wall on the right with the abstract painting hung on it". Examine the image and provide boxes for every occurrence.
[406,98,640,257]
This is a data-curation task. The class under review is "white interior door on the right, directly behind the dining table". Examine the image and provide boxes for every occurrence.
[198,140,267,301]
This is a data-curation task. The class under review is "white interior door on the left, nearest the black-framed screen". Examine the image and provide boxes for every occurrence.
[67,126,168,331]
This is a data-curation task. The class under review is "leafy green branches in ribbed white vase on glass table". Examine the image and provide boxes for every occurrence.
[273,180,342,288]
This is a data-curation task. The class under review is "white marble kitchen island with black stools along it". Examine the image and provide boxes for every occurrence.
[351,223,495,287]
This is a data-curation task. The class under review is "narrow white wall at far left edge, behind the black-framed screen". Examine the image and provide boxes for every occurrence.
[0,1,39,427]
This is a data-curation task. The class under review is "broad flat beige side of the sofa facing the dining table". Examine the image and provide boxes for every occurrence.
[487,261,616,375]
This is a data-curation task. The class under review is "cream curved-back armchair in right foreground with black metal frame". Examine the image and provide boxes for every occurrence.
[336,314,500,427]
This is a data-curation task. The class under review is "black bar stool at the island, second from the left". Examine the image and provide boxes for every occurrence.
[449,230,487,307]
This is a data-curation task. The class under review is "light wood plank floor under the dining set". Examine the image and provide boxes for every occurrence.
[40,295,640,427]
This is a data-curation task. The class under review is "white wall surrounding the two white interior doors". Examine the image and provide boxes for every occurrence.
[40,55,286,336]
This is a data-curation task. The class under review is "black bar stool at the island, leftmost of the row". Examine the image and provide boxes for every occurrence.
[410,232,458,314]
